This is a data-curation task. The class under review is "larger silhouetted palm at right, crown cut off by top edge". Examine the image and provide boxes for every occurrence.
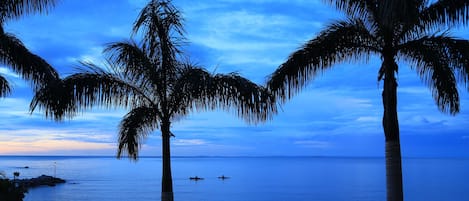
[268,0,469,201]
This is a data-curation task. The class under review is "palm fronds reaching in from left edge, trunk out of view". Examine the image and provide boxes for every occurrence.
[0,0,59,97]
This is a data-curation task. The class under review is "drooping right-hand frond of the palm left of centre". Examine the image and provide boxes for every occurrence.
[170,65,277,123]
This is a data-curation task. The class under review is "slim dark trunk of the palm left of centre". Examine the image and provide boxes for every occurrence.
[161,121,174,201]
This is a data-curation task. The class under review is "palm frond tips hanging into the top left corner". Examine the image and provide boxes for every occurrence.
[0,0,56,23]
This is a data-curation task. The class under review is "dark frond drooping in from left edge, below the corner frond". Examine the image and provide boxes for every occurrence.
[0,33,59,88]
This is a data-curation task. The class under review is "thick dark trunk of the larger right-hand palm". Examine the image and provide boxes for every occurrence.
[382,59,404,201]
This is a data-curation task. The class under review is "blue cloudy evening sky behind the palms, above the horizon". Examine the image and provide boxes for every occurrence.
[0,0,469,157]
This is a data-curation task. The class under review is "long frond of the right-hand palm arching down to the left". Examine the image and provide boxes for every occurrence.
[267,20,381,101]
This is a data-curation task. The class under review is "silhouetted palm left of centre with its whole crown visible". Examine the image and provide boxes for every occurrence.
[31,0,276,201]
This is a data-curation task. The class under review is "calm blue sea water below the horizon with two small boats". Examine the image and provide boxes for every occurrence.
[0,156,469,201]
